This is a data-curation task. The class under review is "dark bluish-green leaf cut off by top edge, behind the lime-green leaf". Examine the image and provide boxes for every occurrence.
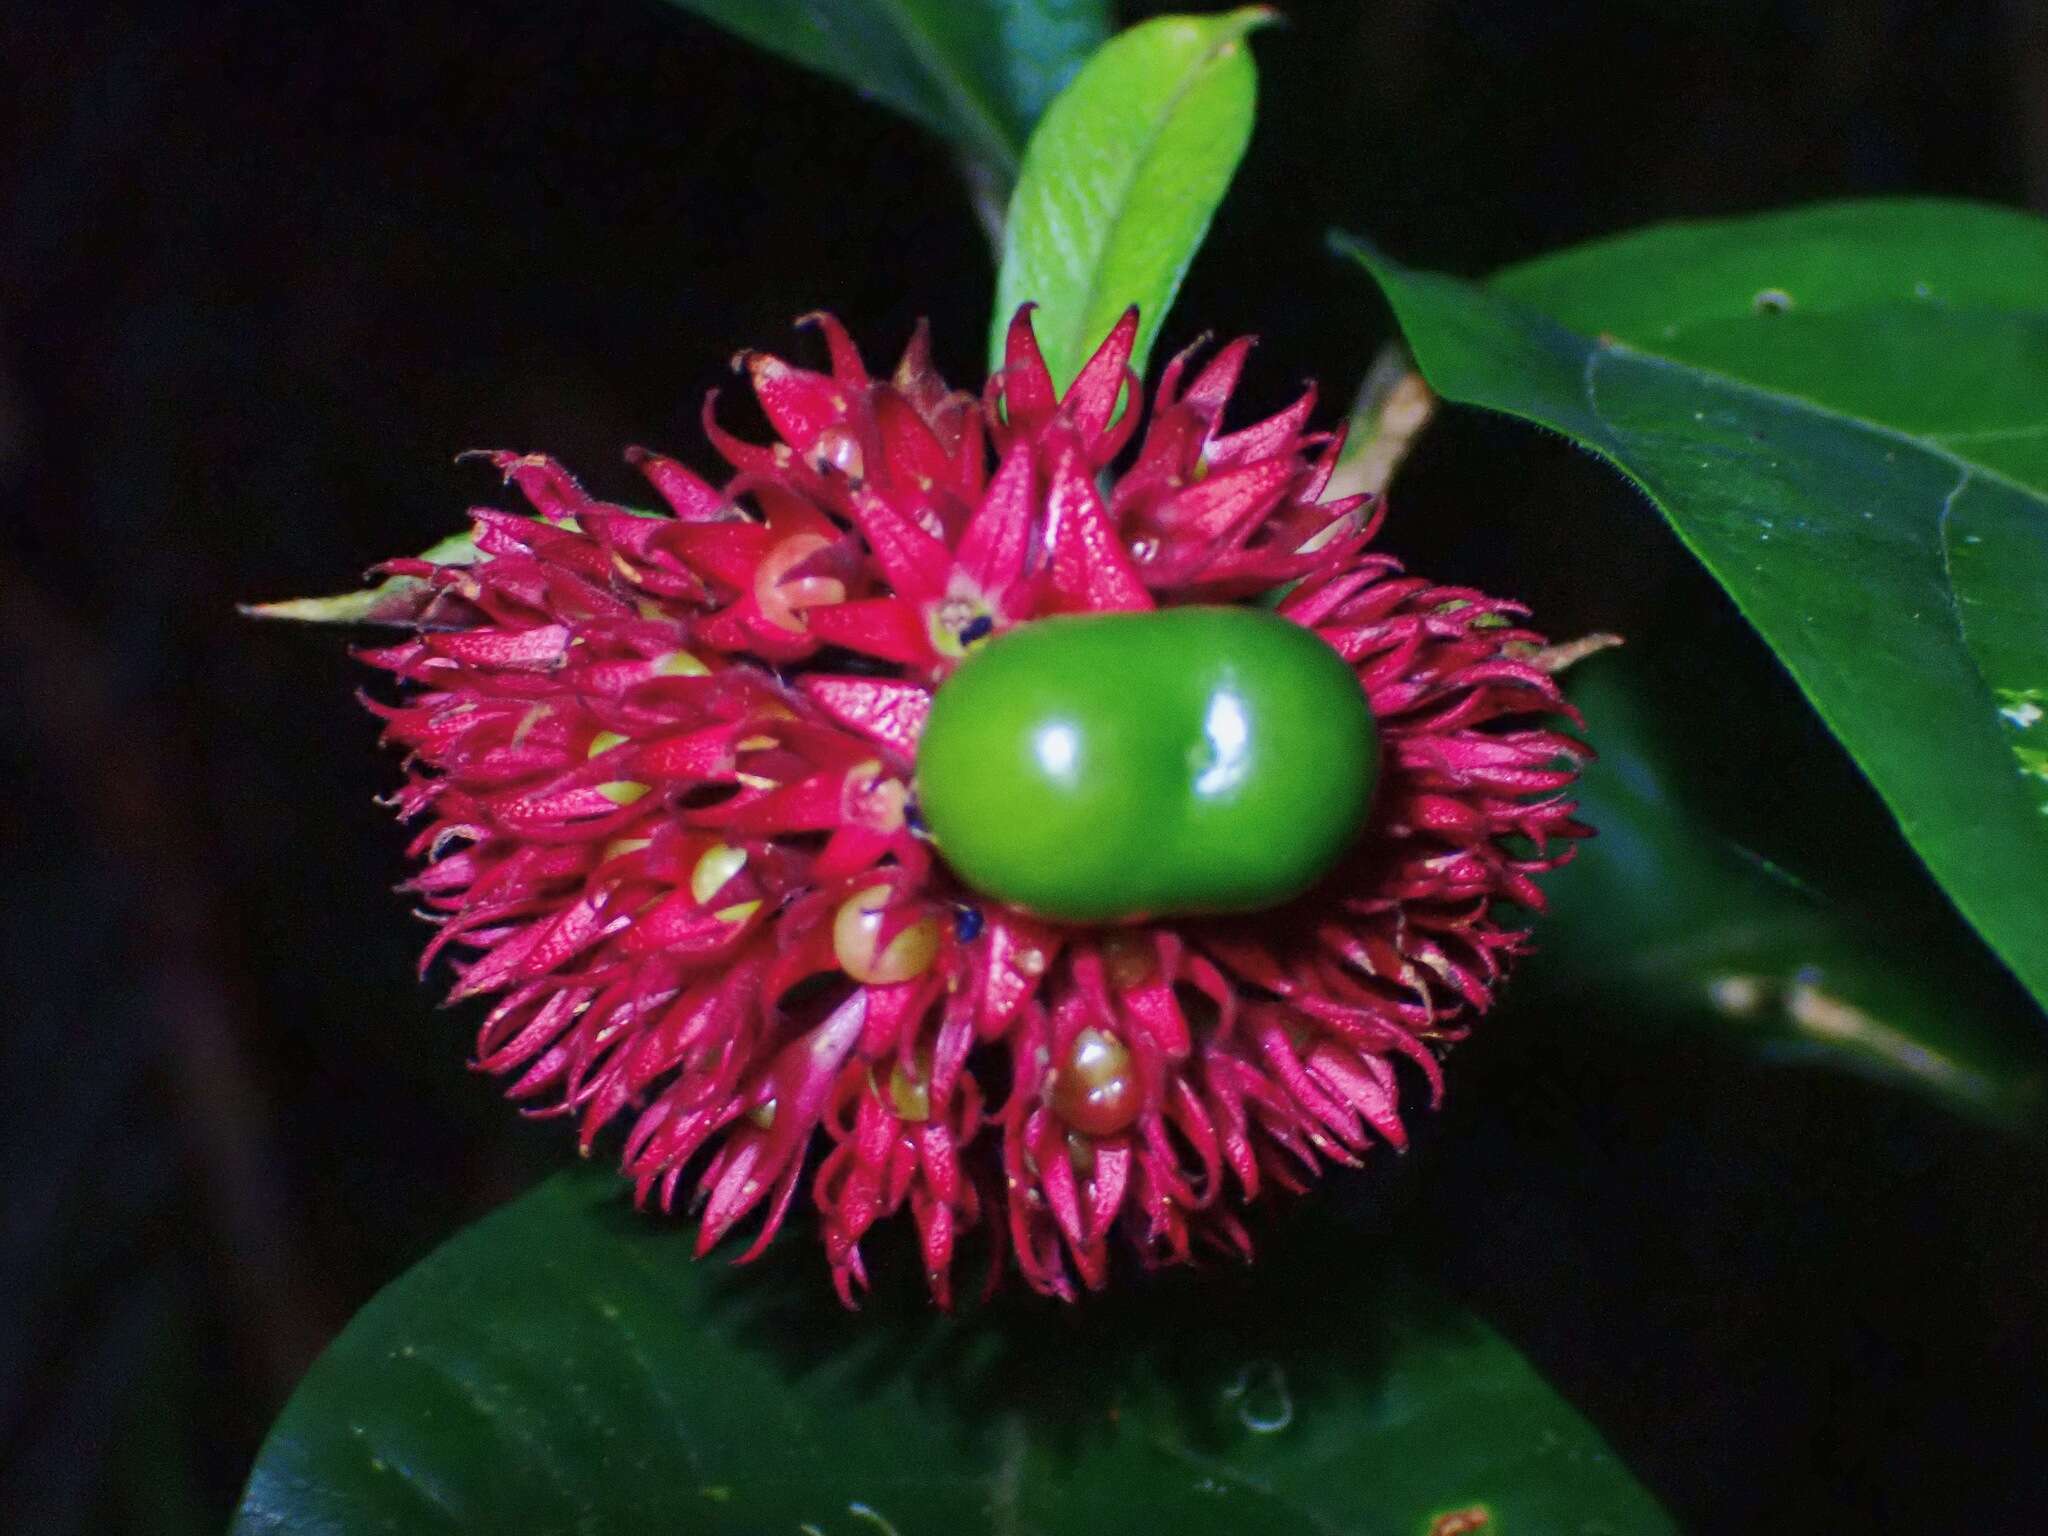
[670,0,1110,186]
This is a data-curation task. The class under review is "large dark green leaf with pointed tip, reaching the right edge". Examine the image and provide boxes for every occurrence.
[1348,203,2048,1004]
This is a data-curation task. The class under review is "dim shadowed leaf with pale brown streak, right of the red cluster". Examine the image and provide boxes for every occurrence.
[1524,653,2048,1130]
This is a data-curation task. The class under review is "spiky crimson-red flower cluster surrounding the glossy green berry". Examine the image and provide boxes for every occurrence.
[369,311,1585,1305]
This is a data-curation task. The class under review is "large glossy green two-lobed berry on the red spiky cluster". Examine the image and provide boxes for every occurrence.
[918,608,1378,924]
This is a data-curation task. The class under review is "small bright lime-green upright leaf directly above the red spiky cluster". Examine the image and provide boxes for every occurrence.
[989,6,1272,389]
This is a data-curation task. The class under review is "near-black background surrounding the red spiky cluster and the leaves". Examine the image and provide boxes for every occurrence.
[0,0,2048,1536]
